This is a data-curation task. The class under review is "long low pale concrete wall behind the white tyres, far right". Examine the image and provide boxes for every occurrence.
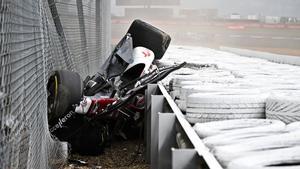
[220,46,300,66]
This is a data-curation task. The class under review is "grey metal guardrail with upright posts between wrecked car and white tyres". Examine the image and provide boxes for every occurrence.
[145,83,222,169]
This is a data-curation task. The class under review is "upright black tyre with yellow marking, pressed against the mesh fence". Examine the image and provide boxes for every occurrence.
[47,70,83,122]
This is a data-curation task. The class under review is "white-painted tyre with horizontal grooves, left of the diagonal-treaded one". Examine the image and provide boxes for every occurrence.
[186,93,267,123]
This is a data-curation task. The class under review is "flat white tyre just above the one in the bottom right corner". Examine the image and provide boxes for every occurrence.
[213,131,300,166]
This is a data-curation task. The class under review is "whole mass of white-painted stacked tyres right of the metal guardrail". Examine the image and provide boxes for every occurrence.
[161,45,300,169]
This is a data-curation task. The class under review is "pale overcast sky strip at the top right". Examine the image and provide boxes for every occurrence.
[181,0,300,17]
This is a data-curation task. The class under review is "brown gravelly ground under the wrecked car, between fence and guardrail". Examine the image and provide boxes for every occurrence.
[64,140,149,169]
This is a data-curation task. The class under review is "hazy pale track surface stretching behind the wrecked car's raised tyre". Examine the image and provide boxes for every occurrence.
[112,21,300,56]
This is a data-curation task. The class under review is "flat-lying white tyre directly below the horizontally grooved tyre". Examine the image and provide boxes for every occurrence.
[193,119,285,138]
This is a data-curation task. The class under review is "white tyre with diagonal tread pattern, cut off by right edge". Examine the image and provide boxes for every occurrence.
[266,95,300,123]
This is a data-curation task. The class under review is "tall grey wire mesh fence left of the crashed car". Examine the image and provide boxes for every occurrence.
[0,0,110,169]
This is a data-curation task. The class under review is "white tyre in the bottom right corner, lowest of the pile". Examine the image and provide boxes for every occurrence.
[227,146,300,169]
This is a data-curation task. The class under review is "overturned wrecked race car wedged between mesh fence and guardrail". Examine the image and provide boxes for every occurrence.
[47,20,185,155]
